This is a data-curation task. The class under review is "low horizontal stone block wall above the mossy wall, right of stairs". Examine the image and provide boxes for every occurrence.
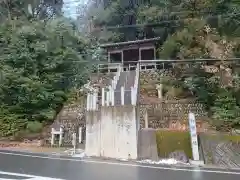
[140,100,207,131]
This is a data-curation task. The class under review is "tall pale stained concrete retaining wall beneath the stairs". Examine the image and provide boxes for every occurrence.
[85,105,138,159]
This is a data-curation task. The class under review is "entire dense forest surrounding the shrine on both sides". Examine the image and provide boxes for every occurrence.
[0,0,240,137]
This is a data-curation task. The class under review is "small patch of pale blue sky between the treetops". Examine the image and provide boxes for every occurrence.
[63,0,88,19]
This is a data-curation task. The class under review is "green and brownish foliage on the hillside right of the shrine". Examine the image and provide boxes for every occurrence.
[154,5,240,131]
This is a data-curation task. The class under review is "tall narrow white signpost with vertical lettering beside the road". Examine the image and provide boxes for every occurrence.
[188,112,199,161]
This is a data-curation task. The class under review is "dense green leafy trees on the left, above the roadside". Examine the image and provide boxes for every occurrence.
[0,6,91,136]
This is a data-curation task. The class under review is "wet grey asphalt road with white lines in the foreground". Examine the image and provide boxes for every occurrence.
[0,151,240,180]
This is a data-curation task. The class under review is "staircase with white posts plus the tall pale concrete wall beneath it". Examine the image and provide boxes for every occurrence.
[85,68,139,159]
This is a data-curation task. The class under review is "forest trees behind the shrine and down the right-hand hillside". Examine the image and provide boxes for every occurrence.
[81,0,240,131]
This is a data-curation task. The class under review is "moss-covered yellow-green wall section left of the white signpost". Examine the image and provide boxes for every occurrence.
[156,130,192,158]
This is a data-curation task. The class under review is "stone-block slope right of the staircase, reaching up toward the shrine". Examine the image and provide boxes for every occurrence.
[140,70,208,131]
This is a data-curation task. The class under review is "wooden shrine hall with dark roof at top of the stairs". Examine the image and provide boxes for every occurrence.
[98,37,160,72]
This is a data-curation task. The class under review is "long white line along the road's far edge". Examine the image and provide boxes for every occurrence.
[0,152,240,175]
